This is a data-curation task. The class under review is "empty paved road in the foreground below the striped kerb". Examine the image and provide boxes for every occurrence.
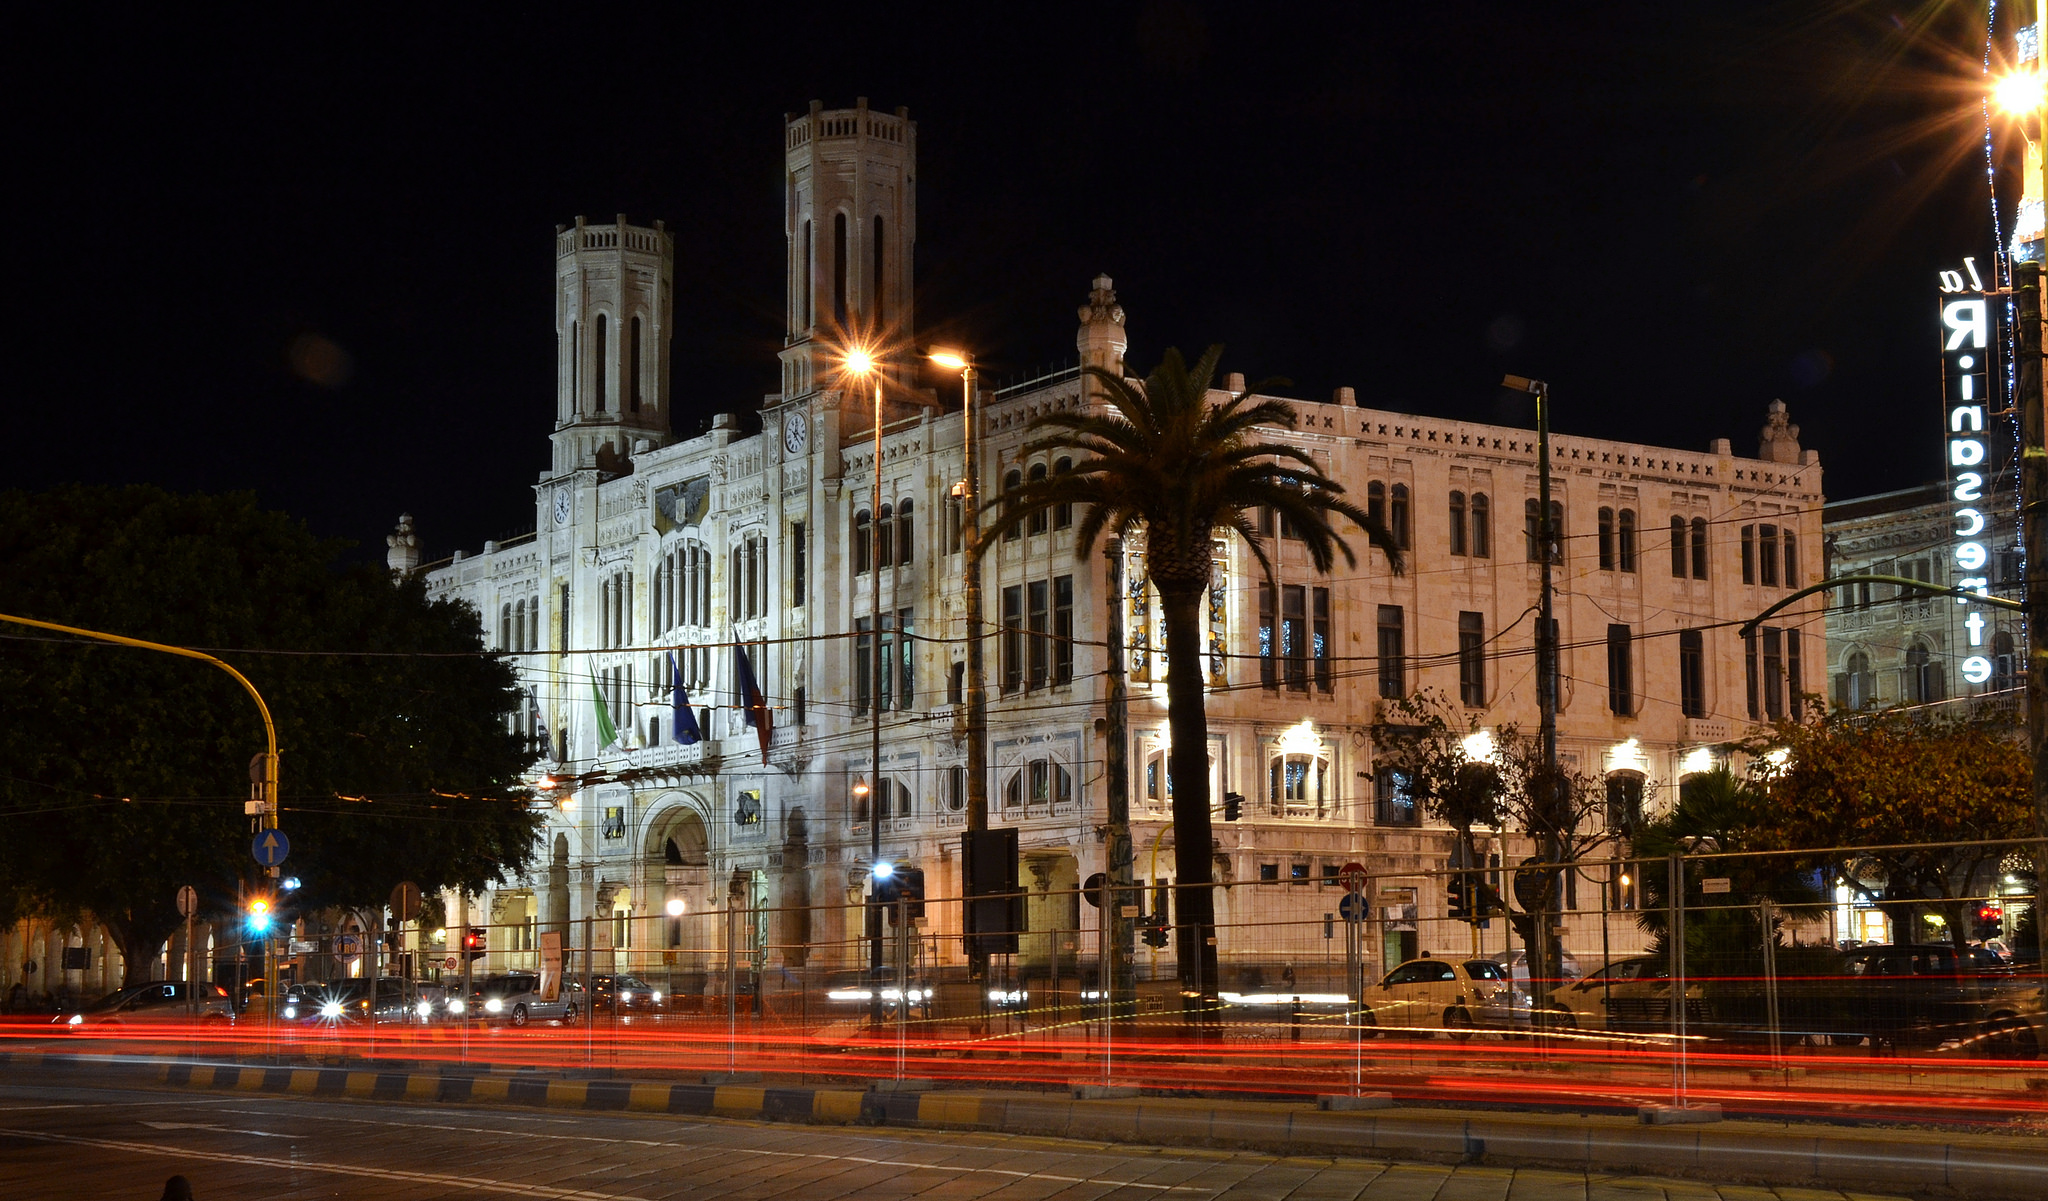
[0,1082,1916,1201]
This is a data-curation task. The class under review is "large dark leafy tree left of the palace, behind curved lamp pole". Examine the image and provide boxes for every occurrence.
[0,486,541,982]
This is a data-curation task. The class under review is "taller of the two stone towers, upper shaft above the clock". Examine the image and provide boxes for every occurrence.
[782,96,918,398]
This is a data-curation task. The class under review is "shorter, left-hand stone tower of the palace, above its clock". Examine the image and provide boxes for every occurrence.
[553,215,676,475]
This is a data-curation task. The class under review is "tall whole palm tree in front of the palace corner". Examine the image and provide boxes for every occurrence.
[977,346,1401,998]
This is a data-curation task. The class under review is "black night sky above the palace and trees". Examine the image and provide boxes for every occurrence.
[4,0,2015,555]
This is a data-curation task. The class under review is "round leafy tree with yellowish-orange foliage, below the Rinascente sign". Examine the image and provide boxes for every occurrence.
[1751,713,2034,945]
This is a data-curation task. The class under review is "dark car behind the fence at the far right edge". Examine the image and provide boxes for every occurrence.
[1782,943,2042,1060]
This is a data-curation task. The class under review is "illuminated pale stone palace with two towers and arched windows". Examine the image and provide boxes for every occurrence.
[411,105,1827,988]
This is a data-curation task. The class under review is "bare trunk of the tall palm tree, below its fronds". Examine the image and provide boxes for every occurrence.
[1159,588,1217,1008]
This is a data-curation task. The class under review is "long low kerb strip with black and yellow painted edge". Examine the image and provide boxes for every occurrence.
[0,1051,2048,1201]
